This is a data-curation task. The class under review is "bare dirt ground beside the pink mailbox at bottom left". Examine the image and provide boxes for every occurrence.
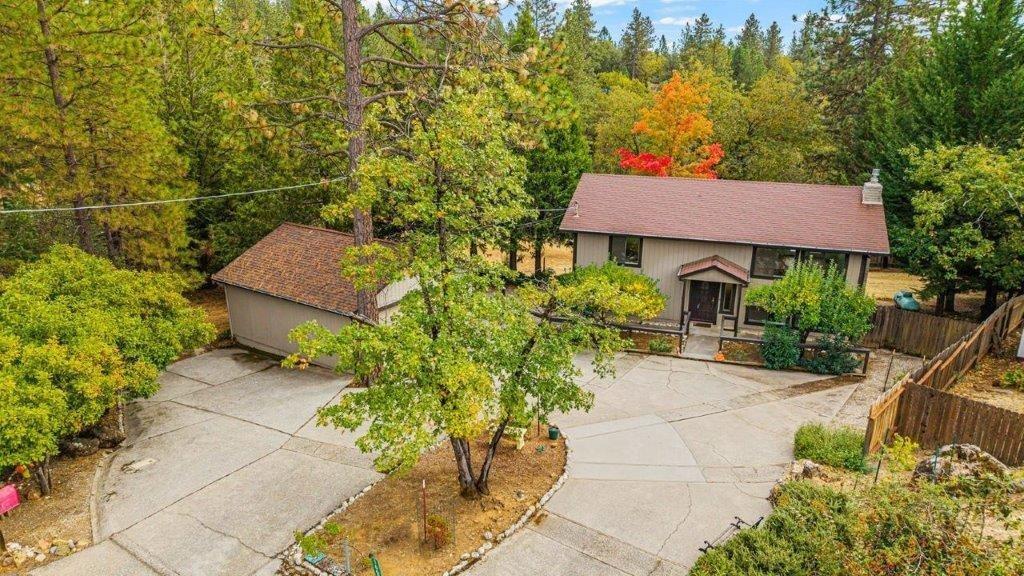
[0,451,104,574]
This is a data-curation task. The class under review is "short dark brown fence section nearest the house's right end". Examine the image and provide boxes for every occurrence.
[861,306,978,358]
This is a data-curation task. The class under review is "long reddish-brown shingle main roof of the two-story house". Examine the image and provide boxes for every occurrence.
[561,174,889,254]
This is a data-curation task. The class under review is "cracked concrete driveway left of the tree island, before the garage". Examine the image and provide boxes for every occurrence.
[34,348,380,576]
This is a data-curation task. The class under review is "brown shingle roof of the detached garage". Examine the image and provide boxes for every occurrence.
[213,222,381,315]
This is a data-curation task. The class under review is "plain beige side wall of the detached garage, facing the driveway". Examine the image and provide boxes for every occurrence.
[224,285,349,368]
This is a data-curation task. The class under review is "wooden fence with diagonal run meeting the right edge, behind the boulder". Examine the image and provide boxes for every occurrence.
[864,296,1024,465]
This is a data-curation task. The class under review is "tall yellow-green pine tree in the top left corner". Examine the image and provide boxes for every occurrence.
[0,0,193,269]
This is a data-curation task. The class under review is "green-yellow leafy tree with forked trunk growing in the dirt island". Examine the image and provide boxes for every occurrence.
[282,76,664,497]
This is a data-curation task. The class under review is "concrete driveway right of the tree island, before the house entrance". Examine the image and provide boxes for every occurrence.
[469,356,855,576]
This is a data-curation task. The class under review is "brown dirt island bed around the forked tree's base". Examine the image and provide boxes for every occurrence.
[311,426,565,576]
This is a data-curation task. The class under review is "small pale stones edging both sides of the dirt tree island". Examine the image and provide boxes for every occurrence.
[278,435,572,576]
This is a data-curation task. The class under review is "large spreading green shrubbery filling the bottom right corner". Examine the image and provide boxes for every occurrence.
[690,481,1024,576]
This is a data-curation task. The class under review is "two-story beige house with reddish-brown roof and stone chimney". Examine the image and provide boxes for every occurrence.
[561,172,889,328]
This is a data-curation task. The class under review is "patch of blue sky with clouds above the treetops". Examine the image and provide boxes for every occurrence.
[581,0,823,43]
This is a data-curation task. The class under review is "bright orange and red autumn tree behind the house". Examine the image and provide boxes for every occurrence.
[616,72,725,178]
